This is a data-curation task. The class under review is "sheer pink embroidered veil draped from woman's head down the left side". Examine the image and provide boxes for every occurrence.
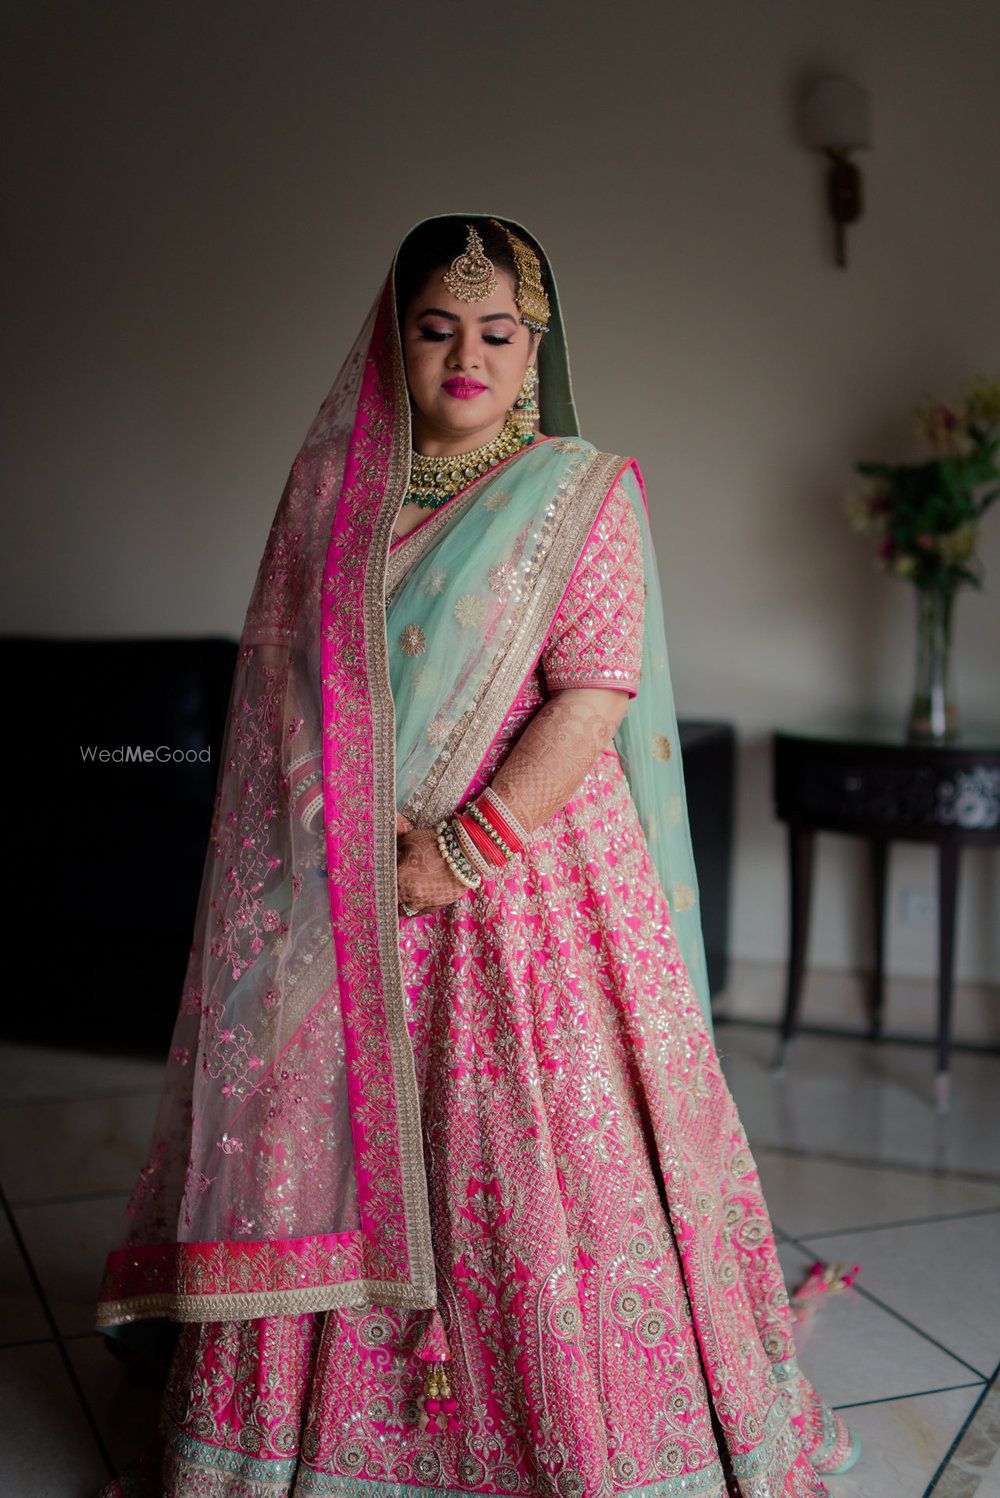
[97,214,601,1327]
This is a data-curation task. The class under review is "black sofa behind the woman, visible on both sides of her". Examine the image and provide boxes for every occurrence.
[0,637,735,1056]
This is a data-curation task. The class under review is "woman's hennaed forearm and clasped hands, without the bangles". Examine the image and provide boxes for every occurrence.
[395,688,629,915]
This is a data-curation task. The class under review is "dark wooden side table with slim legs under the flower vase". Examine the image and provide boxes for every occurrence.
[772,718,1000,1112]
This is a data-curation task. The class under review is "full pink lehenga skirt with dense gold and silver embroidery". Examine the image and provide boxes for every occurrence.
[105,749,856,1498]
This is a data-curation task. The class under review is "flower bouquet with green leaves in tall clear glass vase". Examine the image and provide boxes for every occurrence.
[846,379,1000,742]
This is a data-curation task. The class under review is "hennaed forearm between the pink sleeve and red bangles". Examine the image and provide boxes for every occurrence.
[491,686,630,833]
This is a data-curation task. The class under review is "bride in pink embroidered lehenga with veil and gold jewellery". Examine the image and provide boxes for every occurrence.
[97,214,856,1498]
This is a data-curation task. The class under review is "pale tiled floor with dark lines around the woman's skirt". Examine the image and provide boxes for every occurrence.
[0,1025,1000,1498]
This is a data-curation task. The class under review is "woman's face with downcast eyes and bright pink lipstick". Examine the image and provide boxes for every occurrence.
[403,267,537,451]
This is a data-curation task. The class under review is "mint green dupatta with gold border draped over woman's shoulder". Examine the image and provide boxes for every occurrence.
[386,437,711,1029]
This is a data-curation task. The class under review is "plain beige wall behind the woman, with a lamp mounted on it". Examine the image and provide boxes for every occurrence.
[0,0,1000,1008]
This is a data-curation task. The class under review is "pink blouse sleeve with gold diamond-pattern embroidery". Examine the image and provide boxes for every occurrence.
[542,484,645,697]
